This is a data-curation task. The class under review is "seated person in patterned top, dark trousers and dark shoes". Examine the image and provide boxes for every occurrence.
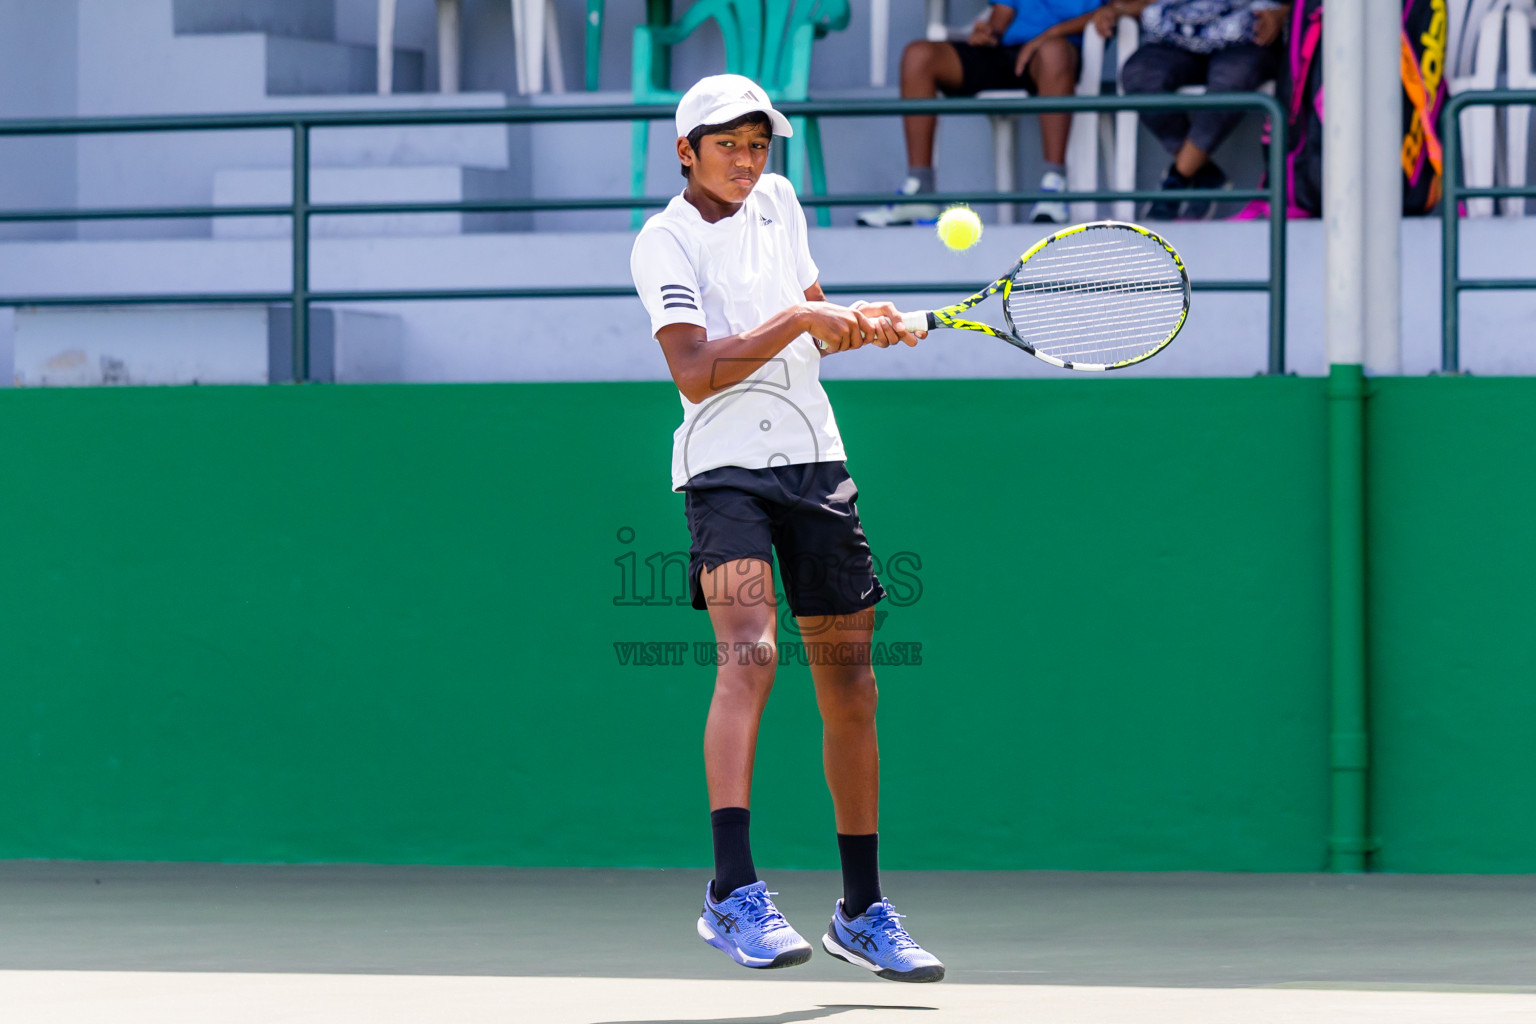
[1112,0,1290,221]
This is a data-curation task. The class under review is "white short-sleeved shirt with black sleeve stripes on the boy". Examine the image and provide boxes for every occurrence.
[630,173,846,490]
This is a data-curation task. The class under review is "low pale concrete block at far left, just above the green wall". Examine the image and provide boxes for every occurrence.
[11,306,404,387]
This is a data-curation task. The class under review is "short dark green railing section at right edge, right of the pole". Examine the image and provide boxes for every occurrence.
[1439,89,1536,373]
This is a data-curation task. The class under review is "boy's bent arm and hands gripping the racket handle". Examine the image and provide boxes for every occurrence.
[656,300,891,404]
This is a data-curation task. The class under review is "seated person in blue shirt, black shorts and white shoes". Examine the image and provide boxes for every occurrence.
[859,0,1100,227]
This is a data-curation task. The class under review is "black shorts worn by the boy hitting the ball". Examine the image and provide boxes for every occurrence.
[682,462,885,616]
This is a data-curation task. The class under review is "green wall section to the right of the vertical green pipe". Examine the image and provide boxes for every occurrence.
[1367,378,1536,872]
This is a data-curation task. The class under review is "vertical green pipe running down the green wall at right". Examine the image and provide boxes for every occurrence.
[1329,362,1370,872]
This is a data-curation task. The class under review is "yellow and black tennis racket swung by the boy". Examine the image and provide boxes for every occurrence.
[902,221,1189,370]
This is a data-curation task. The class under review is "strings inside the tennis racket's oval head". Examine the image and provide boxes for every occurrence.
[1006,226,1186,364]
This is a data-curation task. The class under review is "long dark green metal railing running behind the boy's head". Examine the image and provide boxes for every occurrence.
[0,92,1286,381]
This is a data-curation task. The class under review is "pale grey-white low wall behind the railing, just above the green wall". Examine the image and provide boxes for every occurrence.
[0,218,1536,381]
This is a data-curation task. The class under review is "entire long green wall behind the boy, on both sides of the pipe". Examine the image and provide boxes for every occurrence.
[0,378,1536,870]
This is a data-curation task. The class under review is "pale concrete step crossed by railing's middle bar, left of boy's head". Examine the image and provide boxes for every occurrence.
[214,164,530,238]
